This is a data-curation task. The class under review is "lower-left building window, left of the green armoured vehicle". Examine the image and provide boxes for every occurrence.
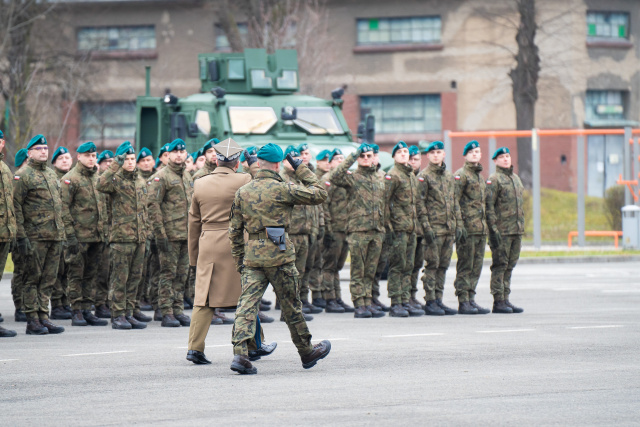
[80,101,136,141]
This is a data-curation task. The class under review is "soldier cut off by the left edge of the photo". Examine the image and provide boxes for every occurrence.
[0,130,17,338]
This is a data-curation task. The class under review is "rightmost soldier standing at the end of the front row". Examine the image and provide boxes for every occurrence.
[487,147,524,313]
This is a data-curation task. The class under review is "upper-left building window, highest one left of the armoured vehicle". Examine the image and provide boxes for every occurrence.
[77,25,156,51]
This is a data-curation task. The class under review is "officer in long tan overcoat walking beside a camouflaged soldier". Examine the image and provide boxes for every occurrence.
[187,139,277,364]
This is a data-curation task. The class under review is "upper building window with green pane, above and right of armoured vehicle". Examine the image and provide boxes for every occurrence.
[357,16,442,46]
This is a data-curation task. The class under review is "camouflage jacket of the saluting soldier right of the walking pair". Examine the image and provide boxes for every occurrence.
[331,153,385,233]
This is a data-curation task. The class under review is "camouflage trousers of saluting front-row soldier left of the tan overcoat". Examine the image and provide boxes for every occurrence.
[109,243,144,318]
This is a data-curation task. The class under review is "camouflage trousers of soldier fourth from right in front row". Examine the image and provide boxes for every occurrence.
[387,233,416,304]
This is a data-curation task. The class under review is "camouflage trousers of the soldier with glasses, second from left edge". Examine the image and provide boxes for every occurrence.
[23,240,62,319]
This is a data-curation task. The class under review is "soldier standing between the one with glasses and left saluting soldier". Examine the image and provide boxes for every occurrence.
[60,142,107,326]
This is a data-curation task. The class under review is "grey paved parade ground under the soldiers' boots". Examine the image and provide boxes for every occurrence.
[0,262,640,425]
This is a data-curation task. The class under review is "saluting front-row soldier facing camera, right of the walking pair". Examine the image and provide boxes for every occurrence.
[331,144,386,318]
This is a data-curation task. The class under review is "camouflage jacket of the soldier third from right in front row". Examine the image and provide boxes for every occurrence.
[418,163,462,236]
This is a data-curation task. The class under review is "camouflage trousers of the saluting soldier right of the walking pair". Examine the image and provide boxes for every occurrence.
[347,231,384,307]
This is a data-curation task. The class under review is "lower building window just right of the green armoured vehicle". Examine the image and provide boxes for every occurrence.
[360,95,442,133]
